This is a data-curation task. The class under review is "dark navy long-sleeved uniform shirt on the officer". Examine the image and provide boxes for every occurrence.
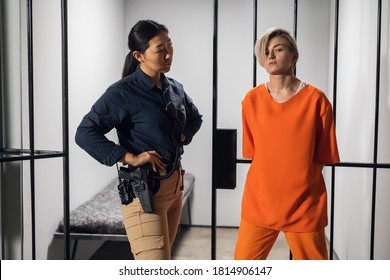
[76,67,202,166]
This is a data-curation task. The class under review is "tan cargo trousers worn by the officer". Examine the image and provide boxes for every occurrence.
[121,170,183,260]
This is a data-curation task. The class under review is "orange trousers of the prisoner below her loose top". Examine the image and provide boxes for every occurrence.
[234,220,328,260]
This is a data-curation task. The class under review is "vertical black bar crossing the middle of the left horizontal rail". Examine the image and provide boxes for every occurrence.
[26,0,36,260]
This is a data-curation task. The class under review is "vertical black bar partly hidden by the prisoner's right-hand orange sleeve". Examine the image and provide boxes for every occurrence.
[329,0,339,260]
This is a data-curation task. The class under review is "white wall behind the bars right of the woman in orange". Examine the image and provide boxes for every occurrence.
[335,0,390,259]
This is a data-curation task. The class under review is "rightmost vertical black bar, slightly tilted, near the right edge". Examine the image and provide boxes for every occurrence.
[370,0,382,260]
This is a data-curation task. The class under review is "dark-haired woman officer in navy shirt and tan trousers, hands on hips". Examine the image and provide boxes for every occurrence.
[76,20,202,260]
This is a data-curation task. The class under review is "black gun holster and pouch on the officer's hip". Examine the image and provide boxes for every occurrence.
[118,166,160,213]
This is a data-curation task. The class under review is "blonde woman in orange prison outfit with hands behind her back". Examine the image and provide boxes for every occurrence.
[234,28,340,260]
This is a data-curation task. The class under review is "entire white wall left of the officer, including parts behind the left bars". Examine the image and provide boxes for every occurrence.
[17,0,124,259]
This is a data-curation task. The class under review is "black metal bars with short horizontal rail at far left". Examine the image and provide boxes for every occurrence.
[0,0,70,260]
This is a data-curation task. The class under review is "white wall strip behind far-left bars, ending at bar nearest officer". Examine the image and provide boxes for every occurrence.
[21,0,62,259]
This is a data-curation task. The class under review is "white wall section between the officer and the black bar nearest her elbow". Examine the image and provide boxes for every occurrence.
[69,0,124,212]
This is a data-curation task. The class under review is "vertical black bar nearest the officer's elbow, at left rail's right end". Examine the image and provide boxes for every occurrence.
[61,0,70,260]
